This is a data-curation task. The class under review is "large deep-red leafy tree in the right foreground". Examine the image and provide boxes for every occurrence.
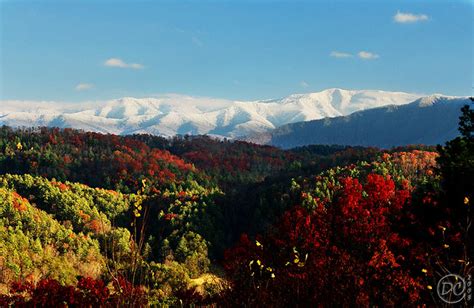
[225,174,426,306]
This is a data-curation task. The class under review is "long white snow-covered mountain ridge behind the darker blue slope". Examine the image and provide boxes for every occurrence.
[0,89,421,138]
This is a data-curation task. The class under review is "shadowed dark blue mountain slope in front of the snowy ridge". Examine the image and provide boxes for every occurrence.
[243,95,471,148]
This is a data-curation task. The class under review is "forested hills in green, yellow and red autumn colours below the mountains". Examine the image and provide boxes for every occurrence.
[0,102,474,307]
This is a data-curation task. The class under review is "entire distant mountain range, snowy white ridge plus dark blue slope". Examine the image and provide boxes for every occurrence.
[0,88,468,148]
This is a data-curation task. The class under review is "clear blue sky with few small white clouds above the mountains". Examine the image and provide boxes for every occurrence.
[0,0,473,101]
